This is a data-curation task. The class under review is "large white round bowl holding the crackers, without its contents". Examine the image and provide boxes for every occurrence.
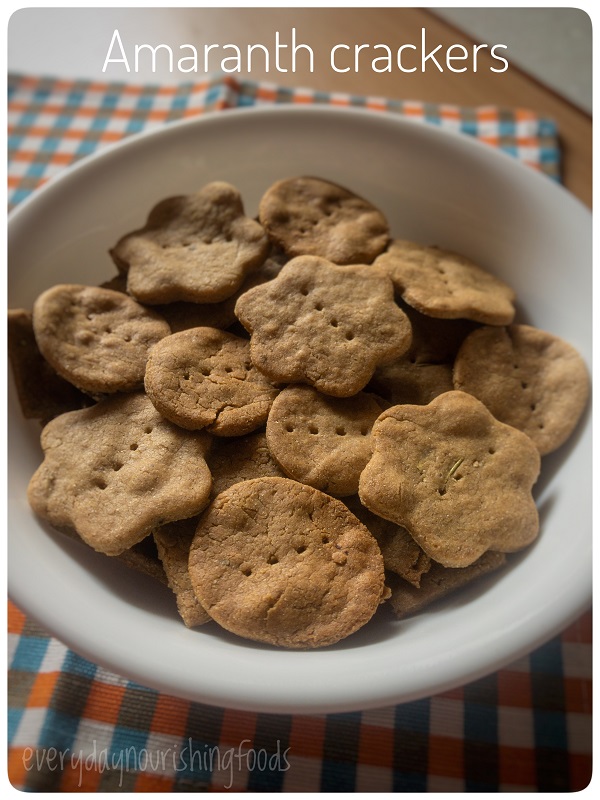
[8,107,592,712]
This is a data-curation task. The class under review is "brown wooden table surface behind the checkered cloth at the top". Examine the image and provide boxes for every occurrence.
[191,8,592,206]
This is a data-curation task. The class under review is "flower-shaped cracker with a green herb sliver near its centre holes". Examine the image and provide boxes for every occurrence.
[359,391,540,567]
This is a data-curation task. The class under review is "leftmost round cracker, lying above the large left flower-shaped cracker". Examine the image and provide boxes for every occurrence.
[33,284,171,395]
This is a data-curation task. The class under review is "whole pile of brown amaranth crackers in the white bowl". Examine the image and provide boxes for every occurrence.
[9,177,589,648]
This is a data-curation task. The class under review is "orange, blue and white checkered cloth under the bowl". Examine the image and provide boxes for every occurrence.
[8,76,591,792]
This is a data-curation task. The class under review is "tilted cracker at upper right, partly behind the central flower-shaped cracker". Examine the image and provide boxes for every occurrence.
[375,239,515,325]
